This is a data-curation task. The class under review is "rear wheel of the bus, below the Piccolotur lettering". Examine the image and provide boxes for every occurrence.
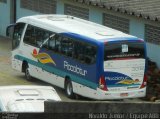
[65,80,75,99]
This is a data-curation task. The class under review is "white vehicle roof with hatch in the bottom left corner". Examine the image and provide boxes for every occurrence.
[0,85,61,112]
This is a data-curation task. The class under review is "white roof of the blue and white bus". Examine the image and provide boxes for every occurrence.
[17,15,141,42]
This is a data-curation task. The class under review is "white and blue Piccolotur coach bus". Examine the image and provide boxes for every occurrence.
[6,14,147,100]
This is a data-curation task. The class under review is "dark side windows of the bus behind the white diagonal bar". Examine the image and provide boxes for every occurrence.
[43,34,97,64]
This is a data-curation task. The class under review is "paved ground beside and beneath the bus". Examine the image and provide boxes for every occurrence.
[0,36,146,102]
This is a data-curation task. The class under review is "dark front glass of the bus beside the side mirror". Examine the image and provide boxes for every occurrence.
[12,23,25,49]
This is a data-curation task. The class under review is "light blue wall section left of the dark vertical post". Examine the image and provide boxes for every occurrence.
[0,0,10,36]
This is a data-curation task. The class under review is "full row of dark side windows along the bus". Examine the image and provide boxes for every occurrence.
[24,25,97,64]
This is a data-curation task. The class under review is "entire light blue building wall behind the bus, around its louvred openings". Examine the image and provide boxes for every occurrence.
[0,0,160,67]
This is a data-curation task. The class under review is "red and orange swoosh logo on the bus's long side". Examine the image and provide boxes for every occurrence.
[32,49,56,65]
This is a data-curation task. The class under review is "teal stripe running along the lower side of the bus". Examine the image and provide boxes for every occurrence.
[14,55,98,89]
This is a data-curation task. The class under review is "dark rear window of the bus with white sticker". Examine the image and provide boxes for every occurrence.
[104,42,145,61]
